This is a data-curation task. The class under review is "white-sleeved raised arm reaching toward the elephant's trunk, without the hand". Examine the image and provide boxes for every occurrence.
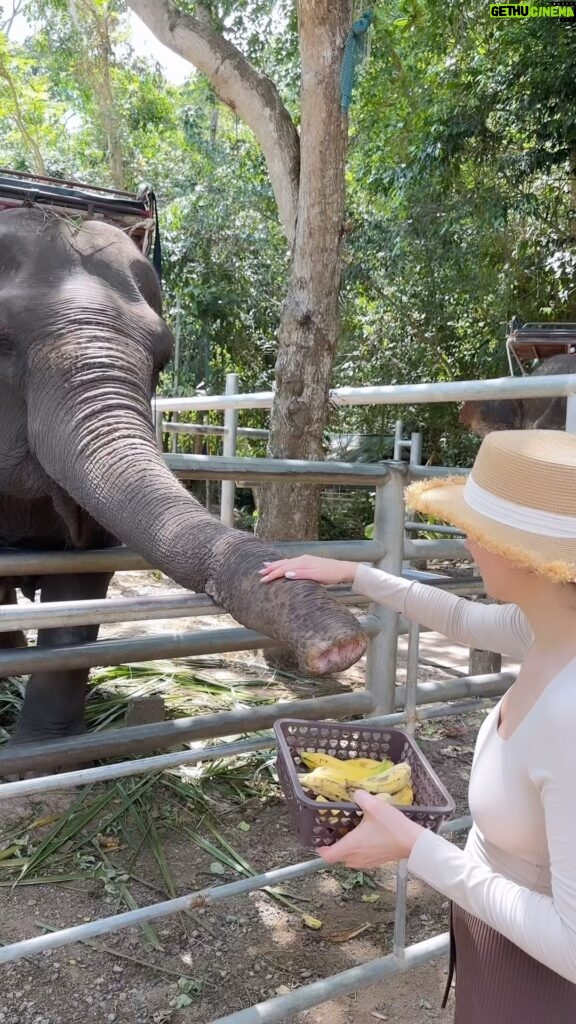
[354,565,533,658]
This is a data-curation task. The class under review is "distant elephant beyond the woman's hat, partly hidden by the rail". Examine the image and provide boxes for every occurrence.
[459,353,576,437]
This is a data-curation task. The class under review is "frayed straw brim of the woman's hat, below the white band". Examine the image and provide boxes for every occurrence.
[405,476,576,583]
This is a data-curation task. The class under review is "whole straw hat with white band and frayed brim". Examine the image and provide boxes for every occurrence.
[406,430,576,583]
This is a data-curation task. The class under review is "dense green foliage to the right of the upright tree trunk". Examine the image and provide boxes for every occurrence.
[337,0,576,465]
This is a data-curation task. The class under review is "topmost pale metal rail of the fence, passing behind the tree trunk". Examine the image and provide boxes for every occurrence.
[154,374,576,413]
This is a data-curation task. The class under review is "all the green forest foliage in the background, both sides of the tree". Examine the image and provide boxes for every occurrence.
[0,0,576,471]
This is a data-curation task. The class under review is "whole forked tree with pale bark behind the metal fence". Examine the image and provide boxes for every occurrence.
[128,0,353,539]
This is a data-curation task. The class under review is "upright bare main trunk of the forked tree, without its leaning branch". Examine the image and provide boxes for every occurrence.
[258,0,352,540]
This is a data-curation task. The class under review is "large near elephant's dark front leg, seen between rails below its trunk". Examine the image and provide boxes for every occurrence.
[12,572,113,742]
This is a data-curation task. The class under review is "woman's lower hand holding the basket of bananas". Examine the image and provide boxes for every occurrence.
[316,790,423,868]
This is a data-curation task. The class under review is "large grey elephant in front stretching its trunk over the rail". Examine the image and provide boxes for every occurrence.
[0,207,367,742]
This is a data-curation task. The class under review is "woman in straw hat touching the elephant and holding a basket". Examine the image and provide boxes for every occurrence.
[261,430,576,1024]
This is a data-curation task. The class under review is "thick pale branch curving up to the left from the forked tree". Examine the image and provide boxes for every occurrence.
[127,0,300,245]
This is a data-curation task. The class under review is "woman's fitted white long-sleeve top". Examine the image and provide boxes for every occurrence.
[354,565,576,983]
